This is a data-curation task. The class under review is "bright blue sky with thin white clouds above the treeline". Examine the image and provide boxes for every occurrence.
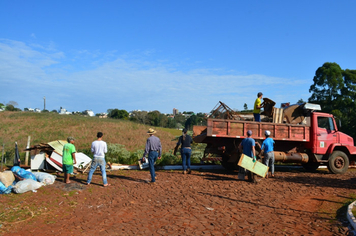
[0,0,356,113]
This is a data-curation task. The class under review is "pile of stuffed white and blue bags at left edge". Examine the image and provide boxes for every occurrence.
[0,166,56,194]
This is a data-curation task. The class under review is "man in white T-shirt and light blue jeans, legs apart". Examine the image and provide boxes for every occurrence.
[87,132,110,187]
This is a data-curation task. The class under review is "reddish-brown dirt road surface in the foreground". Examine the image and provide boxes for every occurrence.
[0,167,356,235]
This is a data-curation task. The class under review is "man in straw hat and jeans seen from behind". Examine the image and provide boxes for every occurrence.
[143,128,162,184]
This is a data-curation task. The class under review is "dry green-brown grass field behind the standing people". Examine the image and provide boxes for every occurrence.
[0,112,186,164]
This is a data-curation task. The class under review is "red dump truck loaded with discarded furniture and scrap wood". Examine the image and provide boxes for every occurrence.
[193,98,356,174]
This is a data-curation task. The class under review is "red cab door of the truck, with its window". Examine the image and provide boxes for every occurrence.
[316,116,338,154]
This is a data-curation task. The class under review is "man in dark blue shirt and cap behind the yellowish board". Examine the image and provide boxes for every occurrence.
[238,130,256,182]
